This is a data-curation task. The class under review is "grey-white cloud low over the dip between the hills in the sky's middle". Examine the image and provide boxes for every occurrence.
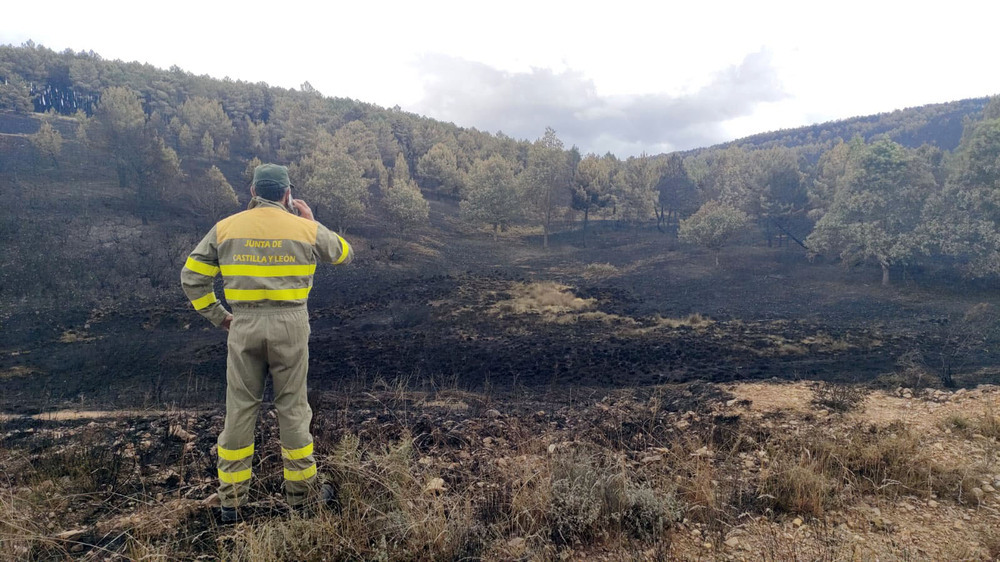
[410,51,786,155]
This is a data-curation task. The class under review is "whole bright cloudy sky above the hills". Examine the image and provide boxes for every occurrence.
[0,0,1000,156]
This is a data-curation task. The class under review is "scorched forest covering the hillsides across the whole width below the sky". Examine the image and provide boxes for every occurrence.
[0,42,1000,308]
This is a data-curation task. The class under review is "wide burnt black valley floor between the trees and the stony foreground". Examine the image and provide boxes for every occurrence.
[0,238,998,413]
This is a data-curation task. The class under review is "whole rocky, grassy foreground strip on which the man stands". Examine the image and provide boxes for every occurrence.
[0,382,1000,560]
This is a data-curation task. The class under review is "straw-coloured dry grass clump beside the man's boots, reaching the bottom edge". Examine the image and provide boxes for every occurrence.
[221,435,484,561]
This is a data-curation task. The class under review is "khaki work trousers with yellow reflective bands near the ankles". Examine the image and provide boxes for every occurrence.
[218,306,316,507]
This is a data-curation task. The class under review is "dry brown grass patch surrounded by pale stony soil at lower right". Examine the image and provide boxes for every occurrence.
[663,398,983,534]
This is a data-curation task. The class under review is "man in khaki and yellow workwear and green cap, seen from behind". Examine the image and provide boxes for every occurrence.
[181,164,354,522]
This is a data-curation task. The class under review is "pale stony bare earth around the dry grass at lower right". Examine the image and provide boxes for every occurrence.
[674,383,1000,560]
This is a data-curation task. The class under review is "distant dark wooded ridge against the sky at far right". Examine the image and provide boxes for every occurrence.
[713,97,989,150]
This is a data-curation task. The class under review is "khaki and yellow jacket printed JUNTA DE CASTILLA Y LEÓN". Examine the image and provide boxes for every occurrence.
[181,197,354,326]
